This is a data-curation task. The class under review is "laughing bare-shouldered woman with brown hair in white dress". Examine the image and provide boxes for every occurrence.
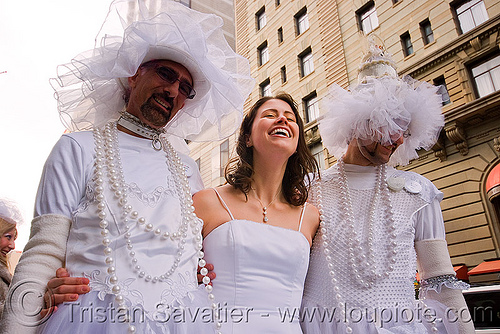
[194,93,319,334]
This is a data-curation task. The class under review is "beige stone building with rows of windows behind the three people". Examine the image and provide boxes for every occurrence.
[190,0,500,280]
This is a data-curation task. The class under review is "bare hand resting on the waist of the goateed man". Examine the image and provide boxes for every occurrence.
[40,268,90,317]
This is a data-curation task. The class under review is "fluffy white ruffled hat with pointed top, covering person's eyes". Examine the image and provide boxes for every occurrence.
[318,39,444,166]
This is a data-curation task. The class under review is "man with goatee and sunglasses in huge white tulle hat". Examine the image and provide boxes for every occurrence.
[2,0,253,333]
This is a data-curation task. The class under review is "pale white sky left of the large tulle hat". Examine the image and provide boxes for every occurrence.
[0,0,111,250]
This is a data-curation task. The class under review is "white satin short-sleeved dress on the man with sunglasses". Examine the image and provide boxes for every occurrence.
[35,131,207,333]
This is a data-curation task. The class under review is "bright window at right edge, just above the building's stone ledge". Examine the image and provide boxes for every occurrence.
[472,55,500,97]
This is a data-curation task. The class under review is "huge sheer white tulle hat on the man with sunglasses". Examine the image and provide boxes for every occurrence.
[51,0,254,141]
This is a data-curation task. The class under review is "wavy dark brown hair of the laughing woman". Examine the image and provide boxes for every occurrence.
[225,93,319,206]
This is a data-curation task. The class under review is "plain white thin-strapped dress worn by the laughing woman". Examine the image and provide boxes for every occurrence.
[203,217,310,334]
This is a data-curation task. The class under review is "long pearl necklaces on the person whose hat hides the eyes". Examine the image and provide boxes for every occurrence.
[317,158,438,334]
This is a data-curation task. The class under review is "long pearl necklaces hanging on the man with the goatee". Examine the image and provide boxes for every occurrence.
[94,122,221,333]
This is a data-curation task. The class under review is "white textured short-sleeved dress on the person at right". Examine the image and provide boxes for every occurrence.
[302,164,460,334]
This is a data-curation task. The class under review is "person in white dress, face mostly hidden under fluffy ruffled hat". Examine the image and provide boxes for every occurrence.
[302,42,474,334]
